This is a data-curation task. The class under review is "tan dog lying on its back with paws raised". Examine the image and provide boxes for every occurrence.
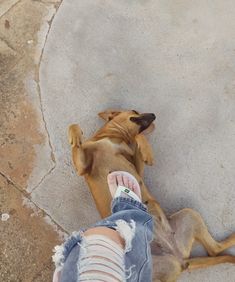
[69,110,235,282]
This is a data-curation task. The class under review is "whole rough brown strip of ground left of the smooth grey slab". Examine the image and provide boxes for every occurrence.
[0,0,64,282]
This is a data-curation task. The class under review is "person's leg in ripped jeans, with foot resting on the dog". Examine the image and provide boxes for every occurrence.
[52,172,152,282]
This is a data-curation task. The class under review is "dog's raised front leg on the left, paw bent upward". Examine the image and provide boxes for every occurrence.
[68,124,91,175]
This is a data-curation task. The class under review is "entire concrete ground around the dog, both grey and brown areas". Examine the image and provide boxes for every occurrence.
[0,0,235,282]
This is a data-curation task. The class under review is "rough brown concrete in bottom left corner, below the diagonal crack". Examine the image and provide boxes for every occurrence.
[0,176,61,282]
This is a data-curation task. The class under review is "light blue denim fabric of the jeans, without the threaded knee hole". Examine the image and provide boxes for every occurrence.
[55,197,153,282]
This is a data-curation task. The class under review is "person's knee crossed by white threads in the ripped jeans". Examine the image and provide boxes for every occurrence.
[77,232,125,282]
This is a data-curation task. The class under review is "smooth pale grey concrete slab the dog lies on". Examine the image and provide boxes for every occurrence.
[32,0,235,282]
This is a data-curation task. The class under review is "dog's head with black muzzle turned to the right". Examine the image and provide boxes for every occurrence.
[99,110,156,136]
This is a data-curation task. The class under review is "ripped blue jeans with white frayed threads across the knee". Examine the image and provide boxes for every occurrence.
[53,197,153,282]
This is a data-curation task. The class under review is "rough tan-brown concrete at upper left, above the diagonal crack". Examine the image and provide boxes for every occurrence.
[0,0,59,192]
